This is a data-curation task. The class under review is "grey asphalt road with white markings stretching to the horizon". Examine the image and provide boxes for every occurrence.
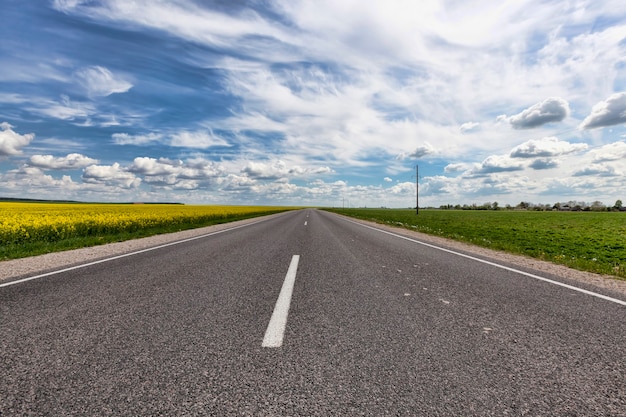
[0,210,626,416]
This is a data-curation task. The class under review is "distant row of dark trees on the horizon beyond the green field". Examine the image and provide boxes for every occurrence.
[439,200,626,211]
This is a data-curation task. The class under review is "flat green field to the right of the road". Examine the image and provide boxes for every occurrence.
[324,209,626,279]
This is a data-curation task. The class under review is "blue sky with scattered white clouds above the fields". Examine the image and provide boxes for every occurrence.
[0,0,626,207]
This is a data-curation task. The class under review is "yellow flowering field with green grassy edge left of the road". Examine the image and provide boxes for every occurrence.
[0,202,289,260]
